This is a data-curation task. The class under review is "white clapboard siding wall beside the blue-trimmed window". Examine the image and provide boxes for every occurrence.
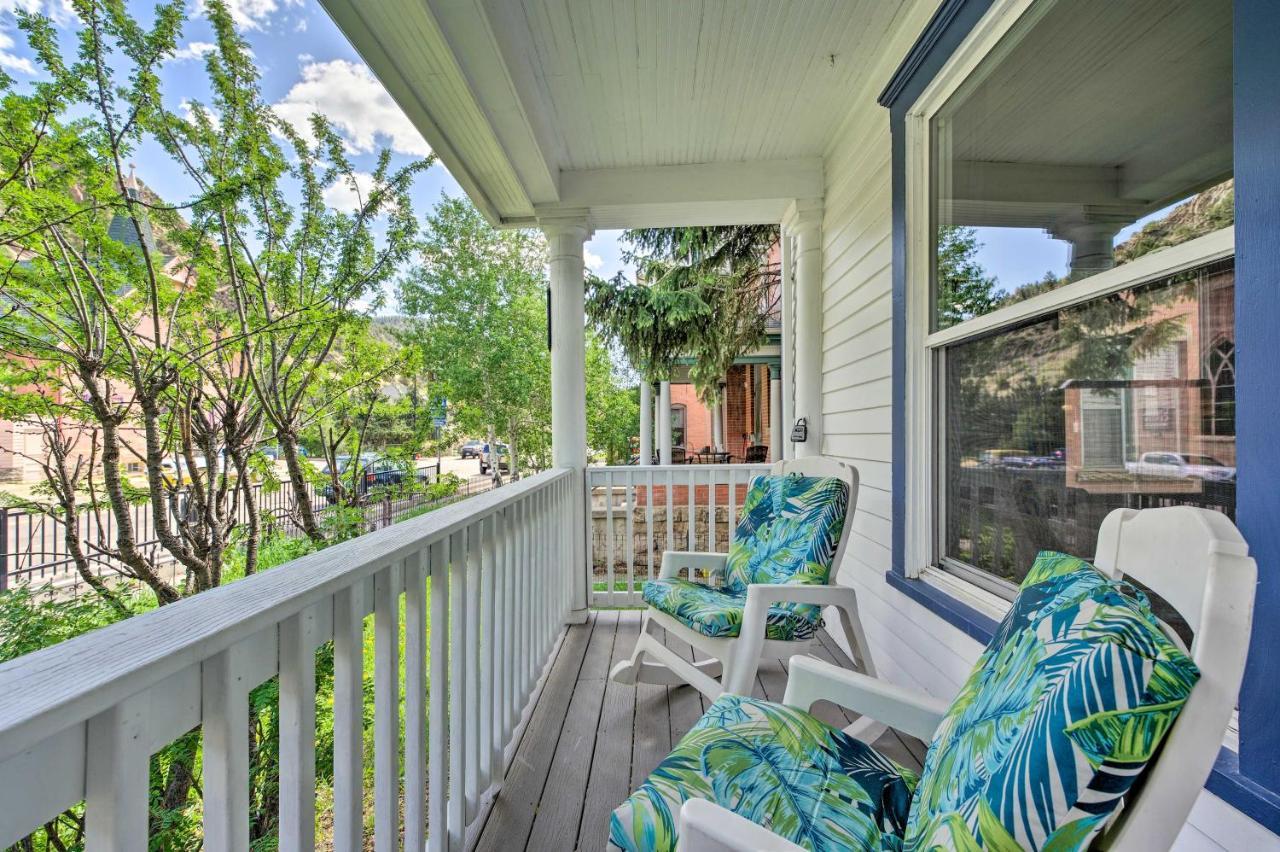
[822,0,1280,852]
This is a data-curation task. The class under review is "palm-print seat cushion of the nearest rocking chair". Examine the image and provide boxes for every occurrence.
[609,695,915,852]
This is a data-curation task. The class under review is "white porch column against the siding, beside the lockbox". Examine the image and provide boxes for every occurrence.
[787,200,822,458]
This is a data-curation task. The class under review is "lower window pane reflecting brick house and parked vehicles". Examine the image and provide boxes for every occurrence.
[942,260,1235,634]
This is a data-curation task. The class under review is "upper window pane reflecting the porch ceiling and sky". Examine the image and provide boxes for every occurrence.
[932,0,1234,329]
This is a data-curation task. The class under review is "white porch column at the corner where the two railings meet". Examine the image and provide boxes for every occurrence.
[539,215,591,622]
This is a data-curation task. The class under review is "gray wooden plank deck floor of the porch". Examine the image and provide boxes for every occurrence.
[477,610,924,852]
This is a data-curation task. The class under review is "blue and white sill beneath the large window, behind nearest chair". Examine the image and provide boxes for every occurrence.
[884,571,1280,834]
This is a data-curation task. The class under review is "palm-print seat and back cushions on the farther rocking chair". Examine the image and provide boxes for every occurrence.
[644,476,849,640]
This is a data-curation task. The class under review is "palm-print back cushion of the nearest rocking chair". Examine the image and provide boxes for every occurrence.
[904,553,1199,852]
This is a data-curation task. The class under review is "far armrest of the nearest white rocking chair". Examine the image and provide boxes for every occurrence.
[782,655,947,742]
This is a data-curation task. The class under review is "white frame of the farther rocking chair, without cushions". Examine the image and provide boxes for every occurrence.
[609,457,876,700]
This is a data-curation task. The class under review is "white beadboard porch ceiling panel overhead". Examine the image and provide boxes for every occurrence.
[499,0,901,170]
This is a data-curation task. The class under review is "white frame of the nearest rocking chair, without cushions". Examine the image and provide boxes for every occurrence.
[677,507,1257,852]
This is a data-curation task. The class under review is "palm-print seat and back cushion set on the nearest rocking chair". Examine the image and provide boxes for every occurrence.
[609,553,1199,852]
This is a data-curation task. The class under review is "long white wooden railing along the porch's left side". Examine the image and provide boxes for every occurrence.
[0,471,581,851]
